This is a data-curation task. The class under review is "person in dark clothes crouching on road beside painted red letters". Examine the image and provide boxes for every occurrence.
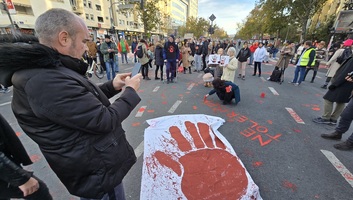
[204,78,240,105]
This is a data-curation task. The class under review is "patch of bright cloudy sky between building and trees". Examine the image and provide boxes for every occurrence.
[198,0,255,34]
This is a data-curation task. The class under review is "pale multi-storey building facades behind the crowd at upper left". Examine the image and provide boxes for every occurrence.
[0,0,198,40]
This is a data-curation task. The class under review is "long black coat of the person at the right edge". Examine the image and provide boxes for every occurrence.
[324,56,353,103]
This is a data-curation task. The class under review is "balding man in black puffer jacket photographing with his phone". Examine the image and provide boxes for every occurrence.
[0,8,141,199]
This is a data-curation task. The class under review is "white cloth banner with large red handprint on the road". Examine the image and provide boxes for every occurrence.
[140,115,262,200]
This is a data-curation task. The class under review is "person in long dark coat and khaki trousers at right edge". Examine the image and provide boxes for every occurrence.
[313,57,353,125]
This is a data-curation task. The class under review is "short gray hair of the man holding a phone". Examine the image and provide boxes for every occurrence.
[34,8,77,44]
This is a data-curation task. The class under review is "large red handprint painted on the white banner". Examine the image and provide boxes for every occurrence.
[153,121,248,199]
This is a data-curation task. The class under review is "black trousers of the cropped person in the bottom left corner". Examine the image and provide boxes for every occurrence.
[0,177,53,200]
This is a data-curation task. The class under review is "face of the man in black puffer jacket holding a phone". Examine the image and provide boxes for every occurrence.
[68,21,89,59]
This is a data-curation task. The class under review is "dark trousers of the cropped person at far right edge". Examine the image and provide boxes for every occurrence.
[336,99,353,143]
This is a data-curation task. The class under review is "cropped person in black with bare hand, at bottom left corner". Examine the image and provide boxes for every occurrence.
[0,114,52,200]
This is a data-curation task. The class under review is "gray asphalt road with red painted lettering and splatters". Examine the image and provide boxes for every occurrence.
[0,58,353,200]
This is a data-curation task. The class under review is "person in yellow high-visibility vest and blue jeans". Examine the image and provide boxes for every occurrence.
[289,41,316,86]
